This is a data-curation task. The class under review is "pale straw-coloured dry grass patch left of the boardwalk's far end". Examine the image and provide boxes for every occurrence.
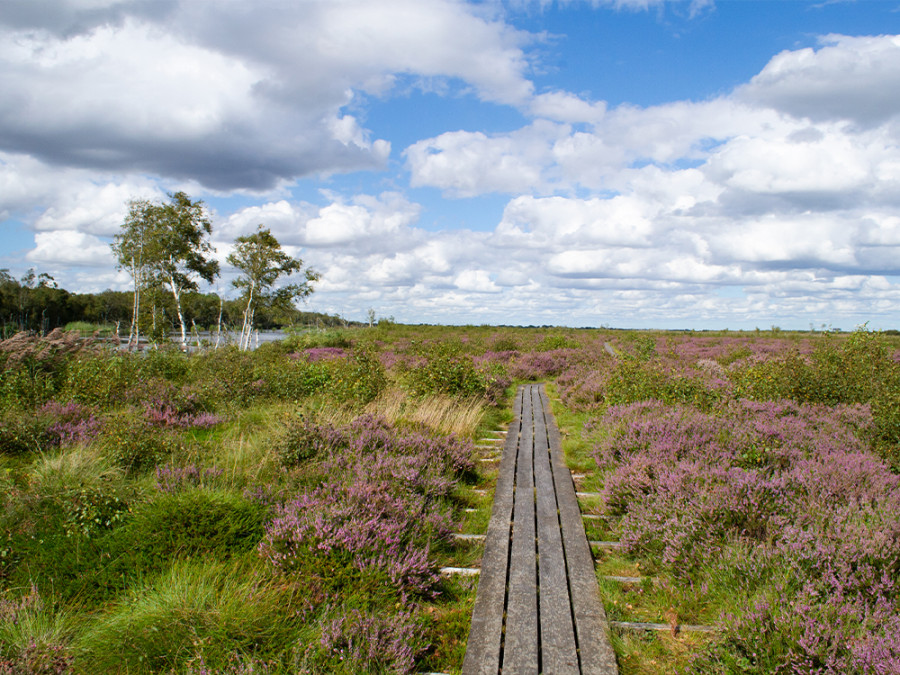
[366,389,484,437]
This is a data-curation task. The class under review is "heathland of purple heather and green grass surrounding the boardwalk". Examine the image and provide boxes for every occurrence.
[0,324,900,675]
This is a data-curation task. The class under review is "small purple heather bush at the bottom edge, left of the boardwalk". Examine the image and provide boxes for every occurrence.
[319,609,424,673]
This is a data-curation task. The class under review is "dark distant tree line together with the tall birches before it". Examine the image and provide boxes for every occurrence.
[0,192,346,349]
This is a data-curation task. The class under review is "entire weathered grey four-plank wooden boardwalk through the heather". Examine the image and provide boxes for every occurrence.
[462,385,618,675]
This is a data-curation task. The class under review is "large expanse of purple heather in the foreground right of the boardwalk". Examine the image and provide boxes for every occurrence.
[586,400,900,674]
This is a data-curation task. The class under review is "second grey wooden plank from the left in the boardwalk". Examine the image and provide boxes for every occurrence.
[503,389,539,675]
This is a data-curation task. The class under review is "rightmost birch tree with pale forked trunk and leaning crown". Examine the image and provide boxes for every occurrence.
[226,225,319,350]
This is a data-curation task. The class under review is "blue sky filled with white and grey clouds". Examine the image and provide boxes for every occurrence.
[0,0,900,329]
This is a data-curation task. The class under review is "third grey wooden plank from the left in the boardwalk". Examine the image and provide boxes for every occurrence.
[532,387,579,675]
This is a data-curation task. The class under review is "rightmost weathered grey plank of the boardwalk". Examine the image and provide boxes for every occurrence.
[540,388,619,675]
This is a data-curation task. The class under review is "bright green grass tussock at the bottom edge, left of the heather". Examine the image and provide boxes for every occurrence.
[74,559,303,673]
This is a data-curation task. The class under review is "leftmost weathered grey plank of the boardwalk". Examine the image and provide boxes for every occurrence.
[462,391,523,675]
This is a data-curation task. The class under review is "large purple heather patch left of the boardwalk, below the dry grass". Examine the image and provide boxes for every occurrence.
[259,416,473,599]
